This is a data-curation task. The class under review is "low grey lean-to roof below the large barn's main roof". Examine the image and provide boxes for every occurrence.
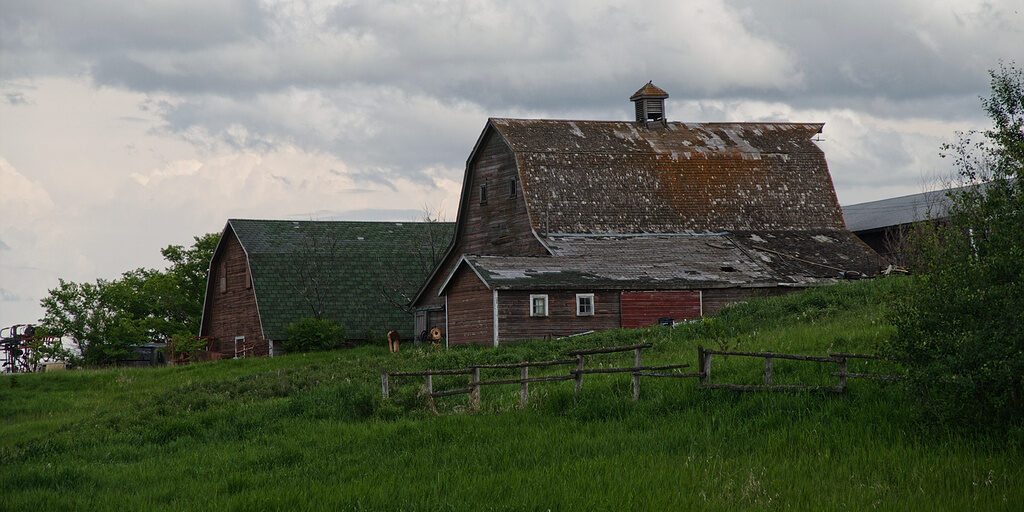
[440,230,882,293]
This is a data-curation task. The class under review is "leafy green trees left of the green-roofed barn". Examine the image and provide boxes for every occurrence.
[41,233,219,365]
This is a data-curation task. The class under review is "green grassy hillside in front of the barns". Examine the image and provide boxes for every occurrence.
[0,280,1024,511]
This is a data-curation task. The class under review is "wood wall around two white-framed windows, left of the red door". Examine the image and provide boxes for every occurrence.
[497,290,620,343]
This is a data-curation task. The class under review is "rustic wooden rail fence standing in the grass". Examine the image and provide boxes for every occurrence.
[381,343,900,412]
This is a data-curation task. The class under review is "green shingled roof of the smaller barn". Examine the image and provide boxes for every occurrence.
[227,219,455,340]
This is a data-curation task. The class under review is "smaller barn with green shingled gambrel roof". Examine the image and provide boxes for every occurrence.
[201,219,453,357]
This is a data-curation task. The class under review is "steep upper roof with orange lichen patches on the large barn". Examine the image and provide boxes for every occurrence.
[488,119,844,233]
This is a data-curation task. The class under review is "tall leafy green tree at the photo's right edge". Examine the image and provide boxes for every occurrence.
[888,65,1024,425]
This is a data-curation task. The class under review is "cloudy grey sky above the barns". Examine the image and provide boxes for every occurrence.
[0,0,1024,327]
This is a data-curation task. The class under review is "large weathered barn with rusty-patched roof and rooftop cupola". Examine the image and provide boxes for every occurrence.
[414,83,885,346]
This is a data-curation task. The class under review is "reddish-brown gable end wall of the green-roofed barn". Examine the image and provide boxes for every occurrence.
[202,228,269,357]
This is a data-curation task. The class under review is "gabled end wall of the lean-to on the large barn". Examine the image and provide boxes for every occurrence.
[446,267,495,345]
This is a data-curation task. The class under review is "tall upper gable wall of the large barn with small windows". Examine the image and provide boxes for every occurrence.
[417,131,548,309]
